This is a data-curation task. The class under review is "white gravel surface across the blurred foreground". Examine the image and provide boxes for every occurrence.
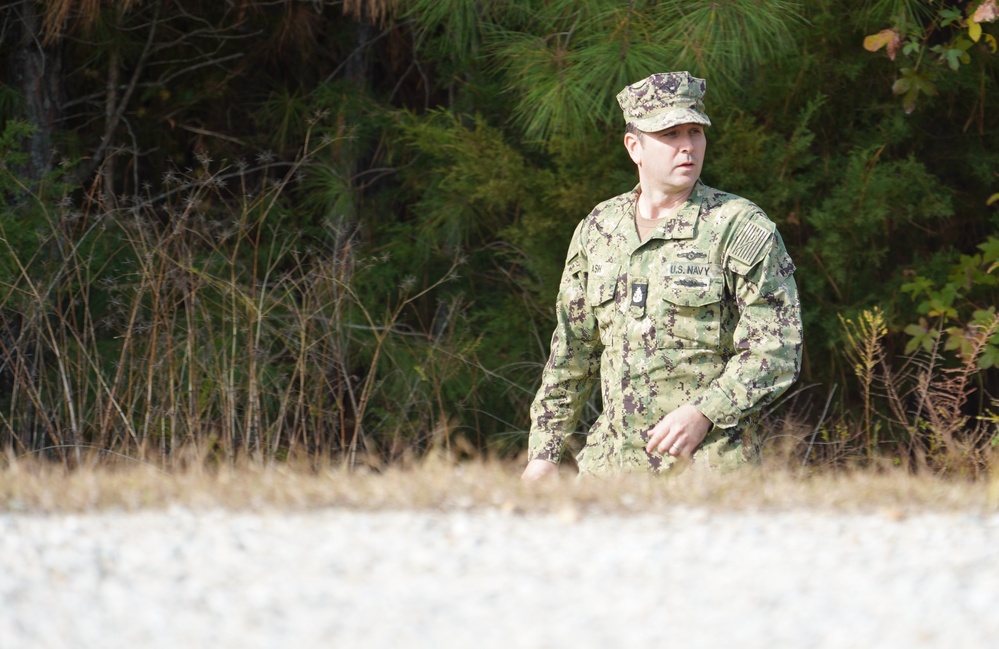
[0,508,999,649]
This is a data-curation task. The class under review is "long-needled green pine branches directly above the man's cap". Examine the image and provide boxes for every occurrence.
[489,0,801,140]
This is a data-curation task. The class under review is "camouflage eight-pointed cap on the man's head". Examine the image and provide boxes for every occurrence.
[617,72,711,133]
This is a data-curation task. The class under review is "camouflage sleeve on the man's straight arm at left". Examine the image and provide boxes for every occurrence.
[528,223,603,463]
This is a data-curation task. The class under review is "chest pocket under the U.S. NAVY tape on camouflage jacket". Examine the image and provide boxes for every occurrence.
[660,273,725,348]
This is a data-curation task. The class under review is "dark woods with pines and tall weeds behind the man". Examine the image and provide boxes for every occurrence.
[0,0,999,475]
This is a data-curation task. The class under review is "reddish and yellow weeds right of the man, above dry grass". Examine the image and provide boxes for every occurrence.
[771,308,999,479]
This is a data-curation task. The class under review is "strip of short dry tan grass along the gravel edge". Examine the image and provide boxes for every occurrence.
[0,450,999,518]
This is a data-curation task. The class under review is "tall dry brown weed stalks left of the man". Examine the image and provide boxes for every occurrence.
[0,130,484,467]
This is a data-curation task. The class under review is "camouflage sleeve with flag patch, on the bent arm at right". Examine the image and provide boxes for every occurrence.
[692,222,802,428]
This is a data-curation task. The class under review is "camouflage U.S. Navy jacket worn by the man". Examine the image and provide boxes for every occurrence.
[529,181,802,473]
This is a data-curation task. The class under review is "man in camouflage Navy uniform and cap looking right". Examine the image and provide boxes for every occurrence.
[522,72,802,480]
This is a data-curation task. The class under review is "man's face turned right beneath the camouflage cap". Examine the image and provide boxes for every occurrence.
[624,124,708,194]
